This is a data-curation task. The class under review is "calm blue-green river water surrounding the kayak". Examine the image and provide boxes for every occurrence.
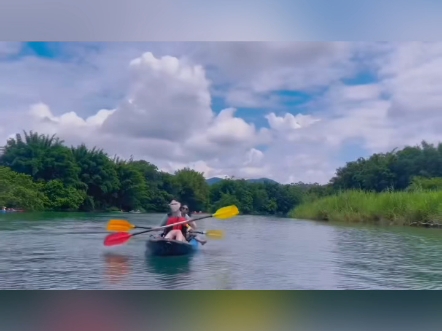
[0,213,442,290]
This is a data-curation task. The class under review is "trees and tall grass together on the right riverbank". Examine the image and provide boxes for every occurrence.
[289,142,442,227]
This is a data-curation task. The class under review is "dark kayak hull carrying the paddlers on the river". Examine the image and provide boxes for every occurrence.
[146,237,200,256]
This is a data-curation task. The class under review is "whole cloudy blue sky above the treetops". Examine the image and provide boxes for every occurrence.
[0,42,442,184]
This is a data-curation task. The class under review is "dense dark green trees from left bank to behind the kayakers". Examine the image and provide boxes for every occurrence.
[0,132,320,215]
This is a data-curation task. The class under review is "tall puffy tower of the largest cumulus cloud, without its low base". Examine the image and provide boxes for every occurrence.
[99,53,214,141]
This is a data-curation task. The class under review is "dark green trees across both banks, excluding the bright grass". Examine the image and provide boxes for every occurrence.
[0,132,442,215]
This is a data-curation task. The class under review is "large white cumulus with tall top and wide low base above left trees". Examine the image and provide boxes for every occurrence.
[12,52,270,180]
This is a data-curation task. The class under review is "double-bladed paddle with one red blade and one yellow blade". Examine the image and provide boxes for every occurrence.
[104,205,239,246]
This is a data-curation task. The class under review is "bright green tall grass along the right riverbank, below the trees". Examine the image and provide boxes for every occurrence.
[289,191,442,227]
